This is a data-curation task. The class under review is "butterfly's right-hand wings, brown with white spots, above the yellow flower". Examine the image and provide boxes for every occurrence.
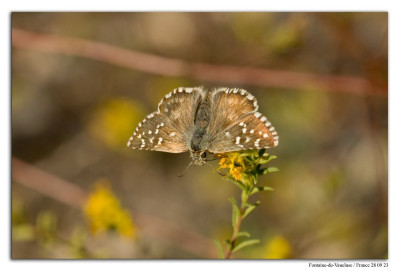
[208,89,279,153]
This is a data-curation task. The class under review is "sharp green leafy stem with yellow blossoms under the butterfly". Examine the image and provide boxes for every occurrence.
[215,149,278,259]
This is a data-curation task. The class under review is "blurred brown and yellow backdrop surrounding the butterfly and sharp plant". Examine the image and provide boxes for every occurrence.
[11,12,388,259]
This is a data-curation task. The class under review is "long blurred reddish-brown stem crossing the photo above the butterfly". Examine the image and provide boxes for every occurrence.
[12,28,387,95]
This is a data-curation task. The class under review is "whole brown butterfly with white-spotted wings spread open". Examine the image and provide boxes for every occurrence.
[127,87,279,166]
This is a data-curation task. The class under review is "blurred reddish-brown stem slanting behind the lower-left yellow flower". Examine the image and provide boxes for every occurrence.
[12,157,216,258]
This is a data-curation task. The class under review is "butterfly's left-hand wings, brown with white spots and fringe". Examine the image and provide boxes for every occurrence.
[127,88,204,153]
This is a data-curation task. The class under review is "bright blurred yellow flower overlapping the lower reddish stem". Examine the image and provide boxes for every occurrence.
[84,181,136,238]
